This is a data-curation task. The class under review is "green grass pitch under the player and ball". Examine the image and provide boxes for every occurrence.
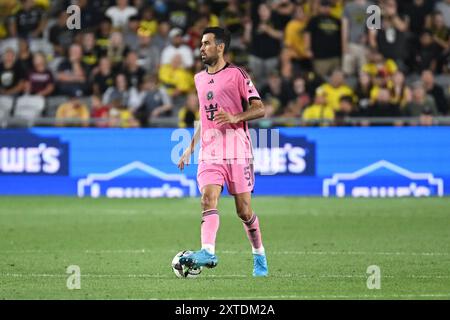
[0,197,450,299]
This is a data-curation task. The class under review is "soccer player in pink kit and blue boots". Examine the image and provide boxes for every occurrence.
[178,27,268,277]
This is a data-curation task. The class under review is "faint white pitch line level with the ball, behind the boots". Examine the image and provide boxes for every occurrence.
[0,249,450,256]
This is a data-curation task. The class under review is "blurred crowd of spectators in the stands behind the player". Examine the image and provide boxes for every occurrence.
[0,0,450,127]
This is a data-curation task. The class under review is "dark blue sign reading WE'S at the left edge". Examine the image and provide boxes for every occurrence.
[0,130,69,176]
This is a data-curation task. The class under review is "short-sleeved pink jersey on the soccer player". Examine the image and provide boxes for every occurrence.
[194,63,260,162]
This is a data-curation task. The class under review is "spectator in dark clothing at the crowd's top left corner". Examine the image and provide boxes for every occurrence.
[9,0,47,39]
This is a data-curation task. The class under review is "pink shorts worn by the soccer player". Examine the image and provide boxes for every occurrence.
[197,159,255,195]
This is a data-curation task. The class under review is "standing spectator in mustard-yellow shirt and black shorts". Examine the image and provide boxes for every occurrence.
[281,5,312,79]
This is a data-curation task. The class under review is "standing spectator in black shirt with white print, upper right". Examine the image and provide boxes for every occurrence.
[369,0,409,69]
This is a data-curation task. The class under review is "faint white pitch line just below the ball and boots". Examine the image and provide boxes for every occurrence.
[0,273,450,279]
